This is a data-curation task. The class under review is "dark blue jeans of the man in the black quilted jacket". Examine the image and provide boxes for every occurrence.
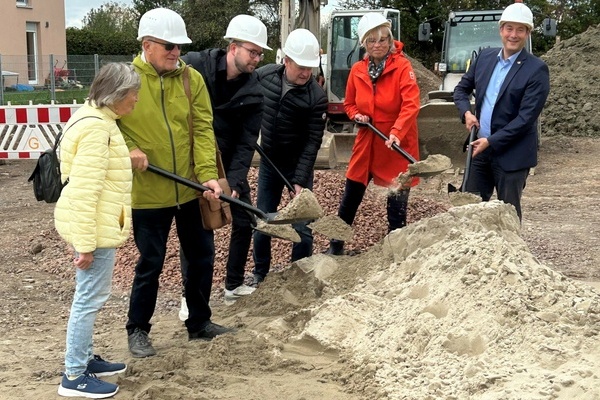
[252,161,313,278]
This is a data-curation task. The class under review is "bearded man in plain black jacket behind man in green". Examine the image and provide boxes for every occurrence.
[179,15,271,310]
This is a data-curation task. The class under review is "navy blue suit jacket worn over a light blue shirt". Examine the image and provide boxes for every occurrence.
[454,48,550,171]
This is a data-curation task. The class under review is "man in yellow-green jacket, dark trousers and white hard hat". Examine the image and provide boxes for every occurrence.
[119,8,231,357]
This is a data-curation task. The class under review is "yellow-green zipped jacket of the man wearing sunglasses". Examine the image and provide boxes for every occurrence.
[119,55,218,208]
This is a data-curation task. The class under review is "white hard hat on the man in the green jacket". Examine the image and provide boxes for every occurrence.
[138,8,192,44]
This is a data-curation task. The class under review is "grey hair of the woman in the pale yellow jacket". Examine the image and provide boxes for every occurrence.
[87,62,142,107]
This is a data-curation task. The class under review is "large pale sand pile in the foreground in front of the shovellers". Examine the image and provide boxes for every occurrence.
[232,201,600,399]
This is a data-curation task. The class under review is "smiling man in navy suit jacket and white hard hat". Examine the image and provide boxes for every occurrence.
[454,3,550,219]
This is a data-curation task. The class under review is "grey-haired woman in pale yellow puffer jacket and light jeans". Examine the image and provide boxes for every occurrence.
[54,63,140,398]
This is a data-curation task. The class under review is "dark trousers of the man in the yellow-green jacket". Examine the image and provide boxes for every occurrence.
[125,200,215,335]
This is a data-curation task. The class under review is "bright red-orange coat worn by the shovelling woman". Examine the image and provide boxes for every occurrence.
[344,41,421,187]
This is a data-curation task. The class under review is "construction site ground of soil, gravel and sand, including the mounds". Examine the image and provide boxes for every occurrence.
[0,27,600,400]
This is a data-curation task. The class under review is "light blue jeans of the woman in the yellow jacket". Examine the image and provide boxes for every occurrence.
[65,249,116,376]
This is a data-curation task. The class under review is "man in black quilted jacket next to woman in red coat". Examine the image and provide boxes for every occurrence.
[253,29,327,286]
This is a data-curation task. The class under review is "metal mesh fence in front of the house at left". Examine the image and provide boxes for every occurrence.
[0,54,134,105]
